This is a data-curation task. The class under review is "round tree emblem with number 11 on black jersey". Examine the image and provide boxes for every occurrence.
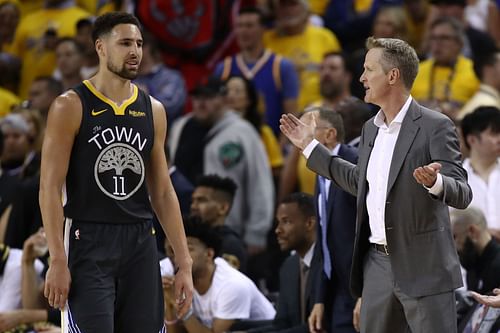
[94,142,145,200]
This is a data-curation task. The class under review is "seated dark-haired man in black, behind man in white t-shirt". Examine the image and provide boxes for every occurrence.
[191,175,247,272]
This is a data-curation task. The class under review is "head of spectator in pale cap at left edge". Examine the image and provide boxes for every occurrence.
[0,114,34,176]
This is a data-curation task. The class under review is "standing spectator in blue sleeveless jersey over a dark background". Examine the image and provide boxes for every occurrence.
[215,7,299,137]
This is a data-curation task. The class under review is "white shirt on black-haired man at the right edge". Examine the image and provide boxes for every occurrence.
[463,158,500,229]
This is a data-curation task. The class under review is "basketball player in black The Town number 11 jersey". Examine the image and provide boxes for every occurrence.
[40,12,193,333]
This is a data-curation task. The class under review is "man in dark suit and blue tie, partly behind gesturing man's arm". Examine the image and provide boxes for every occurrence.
[309,108,358,333]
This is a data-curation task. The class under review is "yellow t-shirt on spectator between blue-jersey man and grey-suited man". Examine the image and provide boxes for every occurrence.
[264,25,341,110]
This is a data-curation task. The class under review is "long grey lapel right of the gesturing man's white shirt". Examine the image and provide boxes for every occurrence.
[387,101,421,195]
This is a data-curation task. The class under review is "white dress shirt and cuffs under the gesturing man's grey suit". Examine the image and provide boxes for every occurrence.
[303,96,443,244]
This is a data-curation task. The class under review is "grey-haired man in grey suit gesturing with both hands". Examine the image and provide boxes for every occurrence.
[281,37,472,333]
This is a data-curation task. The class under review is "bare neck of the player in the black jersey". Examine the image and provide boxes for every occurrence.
[90,71,133,105]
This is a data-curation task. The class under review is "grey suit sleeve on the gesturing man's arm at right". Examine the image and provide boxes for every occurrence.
[430,118,472,209]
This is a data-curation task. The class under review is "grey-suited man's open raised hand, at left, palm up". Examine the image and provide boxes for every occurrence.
[280,112,316,150]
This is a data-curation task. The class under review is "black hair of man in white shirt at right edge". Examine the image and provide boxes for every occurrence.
[461,106,500,149]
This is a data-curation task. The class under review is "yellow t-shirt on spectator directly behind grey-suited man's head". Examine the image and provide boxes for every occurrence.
[411,56,480,105]
